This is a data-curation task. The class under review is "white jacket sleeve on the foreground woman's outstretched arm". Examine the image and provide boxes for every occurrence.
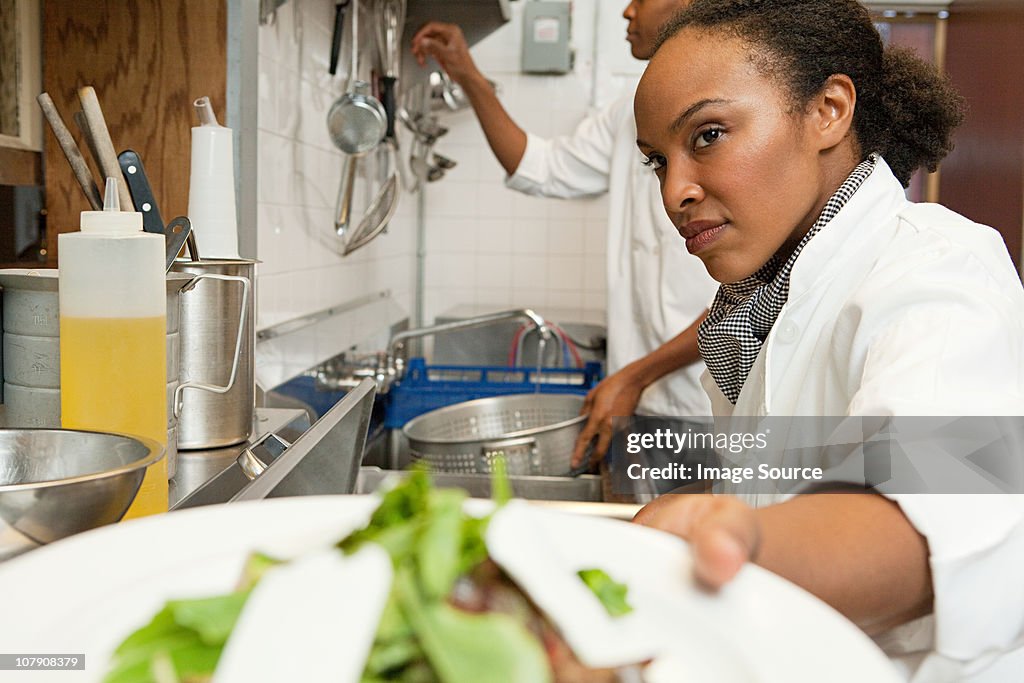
[844,228,1024,680]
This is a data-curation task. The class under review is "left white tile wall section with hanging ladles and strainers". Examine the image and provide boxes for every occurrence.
[257,0,416,328]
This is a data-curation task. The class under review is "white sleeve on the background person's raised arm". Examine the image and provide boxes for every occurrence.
[505,96,640,199]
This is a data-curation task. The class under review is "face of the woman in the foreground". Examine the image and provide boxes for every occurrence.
[634,29,830,283]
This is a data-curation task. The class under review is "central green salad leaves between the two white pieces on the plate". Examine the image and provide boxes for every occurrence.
[339,470,550,683]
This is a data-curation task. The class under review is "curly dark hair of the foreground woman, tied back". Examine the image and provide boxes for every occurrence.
[656,0,964,186]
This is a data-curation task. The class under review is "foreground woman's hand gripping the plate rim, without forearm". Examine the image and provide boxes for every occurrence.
[633,494,761,588]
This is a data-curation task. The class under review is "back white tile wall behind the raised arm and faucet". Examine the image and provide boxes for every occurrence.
[415,0,643,327]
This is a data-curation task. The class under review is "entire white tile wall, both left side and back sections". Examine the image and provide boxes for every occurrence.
[257,0,642,335]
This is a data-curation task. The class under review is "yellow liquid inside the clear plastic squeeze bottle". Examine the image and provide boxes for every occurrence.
[60,315,168,519]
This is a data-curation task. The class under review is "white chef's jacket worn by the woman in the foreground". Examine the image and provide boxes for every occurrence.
[702,160,1024,682]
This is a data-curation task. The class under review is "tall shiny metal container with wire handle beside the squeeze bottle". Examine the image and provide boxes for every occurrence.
[171,259,257,451]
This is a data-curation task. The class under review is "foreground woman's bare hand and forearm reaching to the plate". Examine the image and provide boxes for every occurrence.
[633,493,932,634]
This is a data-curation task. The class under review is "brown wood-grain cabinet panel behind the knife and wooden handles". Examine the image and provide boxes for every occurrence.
[43,0,227,263]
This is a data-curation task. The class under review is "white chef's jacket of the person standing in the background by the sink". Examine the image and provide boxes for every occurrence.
[506,93,717,416]
